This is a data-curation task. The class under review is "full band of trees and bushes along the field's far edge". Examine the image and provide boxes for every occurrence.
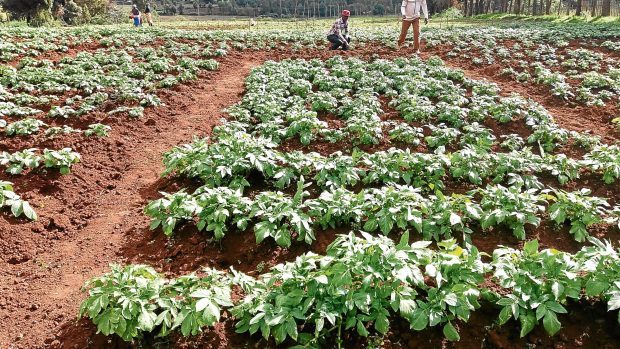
[0,0,620,25]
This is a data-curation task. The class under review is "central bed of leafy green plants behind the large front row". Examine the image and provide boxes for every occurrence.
[150,58,618,246]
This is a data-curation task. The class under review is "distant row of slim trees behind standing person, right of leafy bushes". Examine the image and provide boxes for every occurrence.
[143,0,620,18]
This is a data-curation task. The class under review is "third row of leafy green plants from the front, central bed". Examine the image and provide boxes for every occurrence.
[164,123,620,190]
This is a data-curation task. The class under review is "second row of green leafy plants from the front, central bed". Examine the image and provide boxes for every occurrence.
[145,177,616,247]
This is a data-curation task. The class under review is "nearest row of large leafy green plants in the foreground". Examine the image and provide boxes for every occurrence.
[79,232,620,348]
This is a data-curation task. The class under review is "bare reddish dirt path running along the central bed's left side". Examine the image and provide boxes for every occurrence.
[0,55,261,348]
